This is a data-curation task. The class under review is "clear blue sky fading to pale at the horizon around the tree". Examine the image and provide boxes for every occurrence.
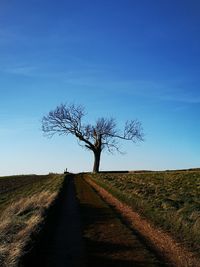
[0,0,200,175]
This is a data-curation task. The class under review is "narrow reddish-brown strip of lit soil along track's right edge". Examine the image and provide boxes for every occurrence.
[87,176,200,267]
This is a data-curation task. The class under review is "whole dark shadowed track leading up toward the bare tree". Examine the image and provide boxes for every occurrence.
[25,176,169,267]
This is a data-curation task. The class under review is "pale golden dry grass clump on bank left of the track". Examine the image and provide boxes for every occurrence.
[0,191,56,267]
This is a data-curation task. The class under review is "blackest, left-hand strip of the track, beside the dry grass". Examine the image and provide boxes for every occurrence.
[24,176,85,267]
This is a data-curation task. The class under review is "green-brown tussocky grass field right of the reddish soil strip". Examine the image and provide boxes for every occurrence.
[90,170,200,256]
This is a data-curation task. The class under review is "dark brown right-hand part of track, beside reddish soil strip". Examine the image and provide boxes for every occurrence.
[75,176,171,267]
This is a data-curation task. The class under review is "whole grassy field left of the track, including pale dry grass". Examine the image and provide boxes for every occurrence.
[0,174,64,267]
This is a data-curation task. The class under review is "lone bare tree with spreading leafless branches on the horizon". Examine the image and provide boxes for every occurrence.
[42,104,143,172]
